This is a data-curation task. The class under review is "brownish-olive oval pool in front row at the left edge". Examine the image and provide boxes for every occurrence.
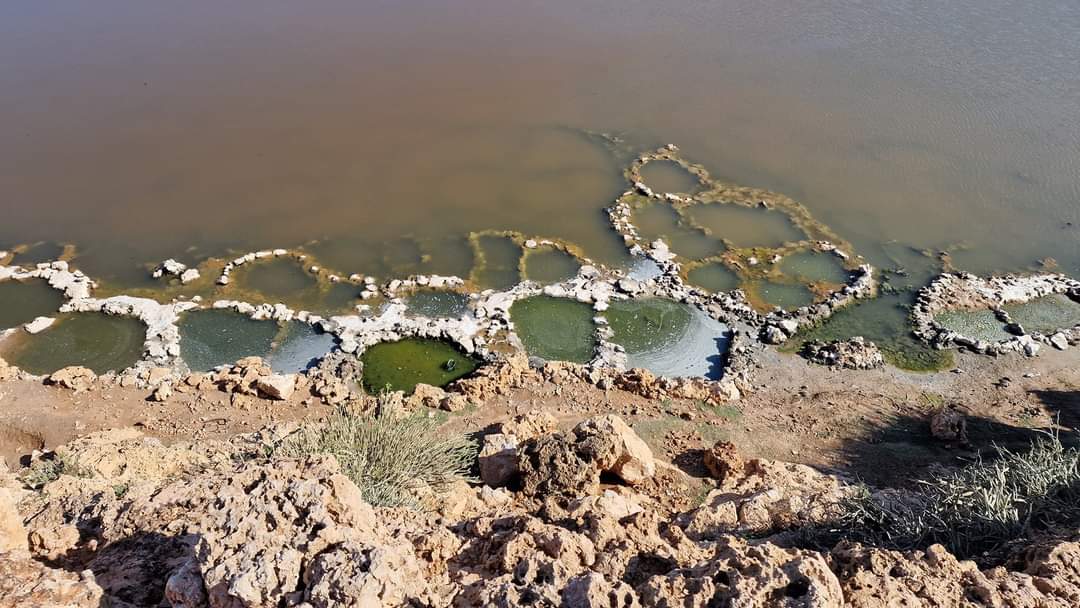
[2,312,146,375]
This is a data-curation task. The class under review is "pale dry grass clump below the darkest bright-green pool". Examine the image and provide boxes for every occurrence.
[275,411,476,508]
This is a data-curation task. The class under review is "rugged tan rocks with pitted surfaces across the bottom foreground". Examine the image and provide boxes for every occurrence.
[0,411,1080,608]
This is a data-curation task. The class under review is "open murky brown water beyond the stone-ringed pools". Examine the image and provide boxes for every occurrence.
[0,0,1080,281]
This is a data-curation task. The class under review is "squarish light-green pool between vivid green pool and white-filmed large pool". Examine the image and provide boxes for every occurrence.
[510,296,597,363]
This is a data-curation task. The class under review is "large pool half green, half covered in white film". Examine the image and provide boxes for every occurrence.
[604,298,731,380]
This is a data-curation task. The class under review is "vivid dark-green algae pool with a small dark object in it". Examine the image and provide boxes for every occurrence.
[360,338,480,394]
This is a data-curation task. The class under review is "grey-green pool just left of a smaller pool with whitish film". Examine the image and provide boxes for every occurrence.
[179,310,281,371]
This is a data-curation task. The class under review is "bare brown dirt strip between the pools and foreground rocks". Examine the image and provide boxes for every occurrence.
[0,349,1080,485]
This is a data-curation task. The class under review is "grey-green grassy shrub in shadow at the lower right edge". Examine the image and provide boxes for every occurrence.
[811,436,1080,557]
